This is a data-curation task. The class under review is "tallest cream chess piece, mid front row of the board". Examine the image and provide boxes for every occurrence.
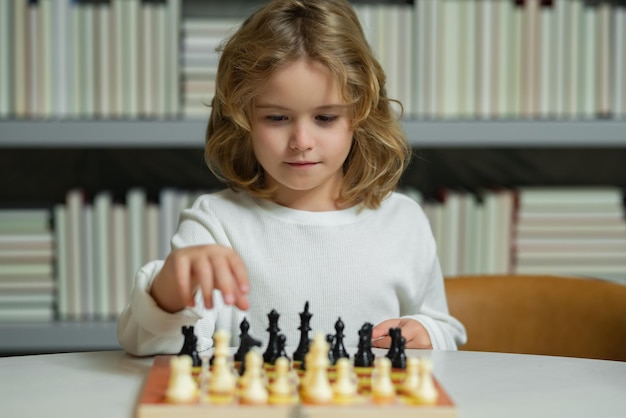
[301,334,333,405]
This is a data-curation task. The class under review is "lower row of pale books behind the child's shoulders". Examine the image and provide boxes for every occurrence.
[0,187,626,322]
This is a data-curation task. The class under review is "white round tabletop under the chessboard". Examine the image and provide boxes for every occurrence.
[0,350,626,418]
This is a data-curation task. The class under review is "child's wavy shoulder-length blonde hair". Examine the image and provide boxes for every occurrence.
[205,0,411,208]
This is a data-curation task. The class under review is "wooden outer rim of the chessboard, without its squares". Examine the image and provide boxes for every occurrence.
[135,356,457,418]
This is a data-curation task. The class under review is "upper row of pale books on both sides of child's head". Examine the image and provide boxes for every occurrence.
[0,0,626,119]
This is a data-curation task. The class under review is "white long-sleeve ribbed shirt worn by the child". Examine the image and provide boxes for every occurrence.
[118,190,466,355]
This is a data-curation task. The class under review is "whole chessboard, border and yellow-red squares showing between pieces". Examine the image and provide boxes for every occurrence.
[136,355,457,418]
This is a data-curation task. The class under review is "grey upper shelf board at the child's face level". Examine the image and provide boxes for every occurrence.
[0,120,626,148]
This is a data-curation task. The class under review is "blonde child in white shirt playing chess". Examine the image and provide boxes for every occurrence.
[118,0,465,355]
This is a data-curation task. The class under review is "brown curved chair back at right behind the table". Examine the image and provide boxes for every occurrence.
[445,275,626,361]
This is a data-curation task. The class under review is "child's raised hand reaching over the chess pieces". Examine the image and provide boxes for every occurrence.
[150,245,250,312]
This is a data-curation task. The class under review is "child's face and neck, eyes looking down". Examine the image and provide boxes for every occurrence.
[252,59,353,211]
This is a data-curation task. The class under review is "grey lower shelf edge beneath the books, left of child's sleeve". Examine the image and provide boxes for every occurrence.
[0,321,120,355]
